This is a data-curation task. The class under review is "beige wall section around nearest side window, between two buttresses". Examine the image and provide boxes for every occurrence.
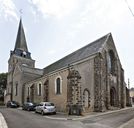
[49,69,68,112]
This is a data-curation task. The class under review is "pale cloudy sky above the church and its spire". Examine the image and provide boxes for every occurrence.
[0,0,134,87]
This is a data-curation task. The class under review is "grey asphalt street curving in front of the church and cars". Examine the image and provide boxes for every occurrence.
[0,107,134,128]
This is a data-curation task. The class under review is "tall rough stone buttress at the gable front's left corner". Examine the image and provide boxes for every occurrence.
[94,54,107,111]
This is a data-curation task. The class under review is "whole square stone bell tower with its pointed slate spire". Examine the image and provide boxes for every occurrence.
[5,19,35,102]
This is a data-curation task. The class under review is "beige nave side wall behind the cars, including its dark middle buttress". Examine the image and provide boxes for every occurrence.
[24,70,68,112]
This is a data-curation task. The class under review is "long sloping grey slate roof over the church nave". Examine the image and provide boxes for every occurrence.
[44,33,111,74]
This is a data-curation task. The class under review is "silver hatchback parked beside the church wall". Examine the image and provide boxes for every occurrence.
[35,102,56,115]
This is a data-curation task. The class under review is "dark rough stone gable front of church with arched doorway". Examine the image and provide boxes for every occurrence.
[94,39,125,111]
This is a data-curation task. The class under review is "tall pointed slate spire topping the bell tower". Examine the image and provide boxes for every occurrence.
[14,19,28,52]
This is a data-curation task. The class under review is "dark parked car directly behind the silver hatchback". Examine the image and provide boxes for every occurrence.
[22,102,36,111]
